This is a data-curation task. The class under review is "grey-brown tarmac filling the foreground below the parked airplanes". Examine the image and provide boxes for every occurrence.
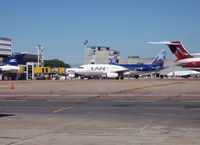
[0,78,200,145]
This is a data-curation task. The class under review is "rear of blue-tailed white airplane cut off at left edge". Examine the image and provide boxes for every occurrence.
[0,52,26,73]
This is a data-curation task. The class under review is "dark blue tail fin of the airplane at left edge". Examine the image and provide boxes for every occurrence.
[5,52,26,66]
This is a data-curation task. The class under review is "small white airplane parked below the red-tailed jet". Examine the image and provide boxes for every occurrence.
[167,70,200,78]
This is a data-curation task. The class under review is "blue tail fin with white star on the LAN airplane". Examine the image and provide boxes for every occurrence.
[151,49,167,66]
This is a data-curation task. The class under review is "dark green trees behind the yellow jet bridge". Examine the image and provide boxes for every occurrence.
[44,59,70,68]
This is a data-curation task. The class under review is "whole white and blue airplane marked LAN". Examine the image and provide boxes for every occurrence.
[66,49,166,78]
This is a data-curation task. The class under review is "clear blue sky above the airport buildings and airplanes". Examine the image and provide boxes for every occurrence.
[0,0,200,65]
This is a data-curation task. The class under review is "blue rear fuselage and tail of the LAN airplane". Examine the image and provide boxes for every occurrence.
[111,49,167,76]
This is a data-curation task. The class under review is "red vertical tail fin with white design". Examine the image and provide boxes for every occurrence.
[168,41,194,60]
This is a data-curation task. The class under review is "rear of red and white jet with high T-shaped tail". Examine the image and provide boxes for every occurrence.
[148,41,200,71]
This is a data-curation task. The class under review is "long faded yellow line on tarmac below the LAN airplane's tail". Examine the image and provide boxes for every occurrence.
[120,82,183,93]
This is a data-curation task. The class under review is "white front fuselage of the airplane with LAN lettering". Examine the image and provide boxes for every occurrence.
[66,64,129,78]
